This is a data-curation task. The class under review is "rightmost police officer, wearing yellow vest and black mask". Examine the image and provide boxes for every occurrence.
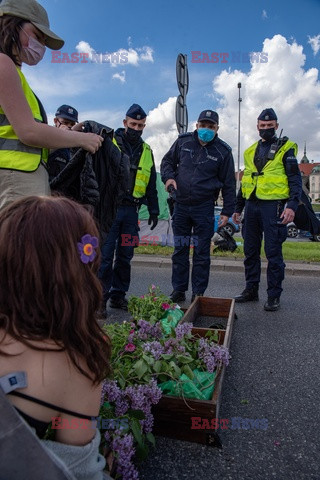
[232,108,302,312]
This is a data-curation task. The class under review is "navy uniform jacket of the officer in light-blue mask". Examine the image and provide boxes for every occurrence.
[161,130,236,217]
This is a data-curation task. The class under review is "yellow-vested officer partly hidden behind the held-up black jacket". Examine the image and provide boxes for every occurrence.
[99,103,159,316]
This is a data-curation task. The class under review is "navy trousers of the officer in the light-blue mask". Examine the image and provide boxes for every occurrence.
[172,201,214,294]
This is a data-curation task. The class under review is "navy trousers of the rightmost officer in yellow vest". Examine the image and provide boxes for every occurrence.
[242,199,287,298]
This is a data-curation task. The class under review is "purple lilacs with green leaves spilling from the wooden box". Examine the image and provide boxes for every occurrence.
[100,285,229,480]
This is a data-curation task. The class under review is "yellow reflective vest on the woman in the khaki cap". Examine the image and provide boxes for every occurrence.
[0,67,48,172]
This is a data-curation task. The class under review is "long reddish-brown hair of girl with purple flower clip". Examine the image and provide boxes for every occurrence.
[0,196,111,383]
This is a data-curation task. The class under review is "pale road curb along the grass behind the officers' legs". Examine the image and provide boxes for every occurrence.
[132,255,320,277]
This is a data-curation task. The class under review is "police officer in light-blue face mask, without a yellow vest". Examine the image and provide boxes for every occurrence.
[161,110,236,302]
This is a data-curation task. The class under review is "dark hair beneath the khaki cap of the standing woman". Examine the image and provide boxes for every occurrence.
[0,15,26,65]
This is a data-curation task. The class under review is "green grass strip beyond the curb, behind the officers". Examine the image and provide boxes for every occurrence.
[135,237,320,262]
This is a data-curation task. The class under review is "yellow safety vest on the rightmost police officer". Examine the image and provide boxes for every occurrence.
[242,140,298,200]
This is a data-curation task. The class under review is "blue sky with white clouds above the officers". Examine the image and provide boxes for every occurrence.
[25,0,320,169]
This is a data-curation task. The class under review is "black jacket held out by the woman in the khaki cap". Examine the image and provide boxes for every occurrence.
[50,121,129,234]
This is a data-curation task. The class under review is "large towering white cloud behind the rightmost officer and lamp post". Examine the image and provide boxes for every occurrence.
[213,35,320,165]
